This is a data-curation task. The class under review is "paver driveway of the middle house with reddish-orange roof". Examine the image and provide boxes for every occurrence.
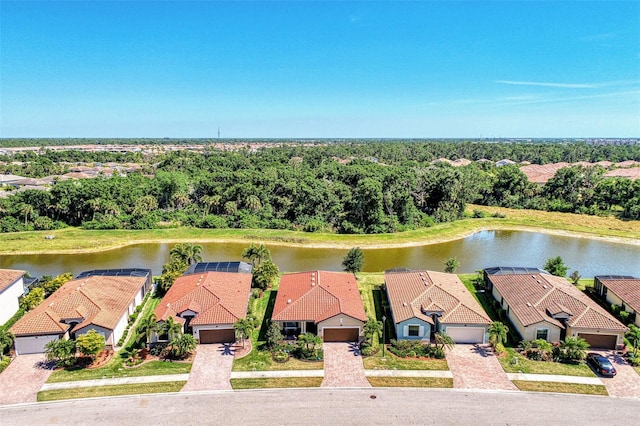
[322,343,371,388]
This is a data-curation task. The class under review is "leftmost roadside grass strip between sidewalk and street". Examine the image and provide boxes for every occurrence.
[37,381,187,402]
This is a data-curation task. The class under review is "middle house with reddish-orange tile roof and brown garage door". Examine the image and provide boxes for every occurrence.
[271,271,367,342]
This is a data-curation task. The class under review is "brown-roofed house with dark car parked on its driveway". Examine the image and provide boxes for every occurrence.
[485,268,627,349]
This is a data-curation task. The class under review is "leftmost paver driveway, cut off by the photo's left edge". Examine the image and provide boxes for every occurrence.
[0,354,52,405]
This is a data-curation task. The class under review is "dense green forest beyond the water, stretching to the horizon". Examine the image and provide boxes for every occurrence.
[0,142,640,233]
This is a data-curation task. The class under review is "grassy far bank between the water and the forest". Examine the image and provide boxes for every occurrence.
[0,206,640,255]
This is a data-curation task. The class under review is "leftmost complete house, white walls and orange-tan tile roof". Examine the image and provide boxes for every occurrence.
[10,269,151,355]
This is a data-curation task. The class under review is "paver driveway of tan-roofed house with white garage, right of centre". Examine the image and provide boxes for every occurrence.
[447,345,518,390]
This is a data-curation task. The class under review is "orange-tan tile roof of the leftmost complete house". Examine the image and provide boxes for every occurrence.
[11,276,146,336]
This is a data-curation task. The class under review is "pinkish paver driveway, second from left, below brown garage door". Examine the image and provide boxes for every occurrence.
[182,344,234,392]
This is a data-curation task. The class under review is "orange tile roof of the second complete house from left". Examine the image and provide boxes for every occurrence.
[155,272,252,325]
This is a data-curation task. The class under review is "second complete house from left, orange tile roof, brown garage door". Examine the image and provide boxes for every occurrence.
[155,272,252,343]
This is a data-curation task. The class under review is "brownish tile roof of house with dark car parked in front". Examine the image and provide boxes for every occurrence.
[488,274,626,331]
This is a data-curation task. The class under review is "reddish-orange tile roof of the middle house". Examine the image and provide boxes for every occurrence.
[271,271,367,323]
